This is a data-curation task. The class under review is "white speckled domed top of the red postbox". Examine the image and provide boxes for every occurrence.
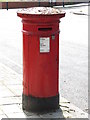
[17,7,63,15]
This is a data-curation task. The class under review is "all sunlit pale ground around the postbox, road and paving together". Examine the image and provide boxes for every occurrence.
[0,2,89,118]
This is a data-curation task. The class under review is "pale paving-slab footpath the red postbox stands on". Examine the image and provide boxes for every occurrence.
[0,58,88,119]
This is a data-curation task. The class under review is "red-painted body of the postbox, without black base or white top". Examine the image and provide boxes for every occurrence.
[17,10,65,97]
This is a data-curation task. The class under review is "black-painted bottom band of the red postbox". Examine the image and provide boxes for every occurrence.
[22,94,59,112]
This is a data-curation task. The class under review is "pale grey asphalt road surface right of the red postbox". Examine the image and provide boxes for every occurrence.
[55,4,90,112]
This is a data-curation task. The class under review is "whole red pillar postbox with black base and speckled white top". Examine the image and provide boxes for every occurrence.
[17,7,65,112]
